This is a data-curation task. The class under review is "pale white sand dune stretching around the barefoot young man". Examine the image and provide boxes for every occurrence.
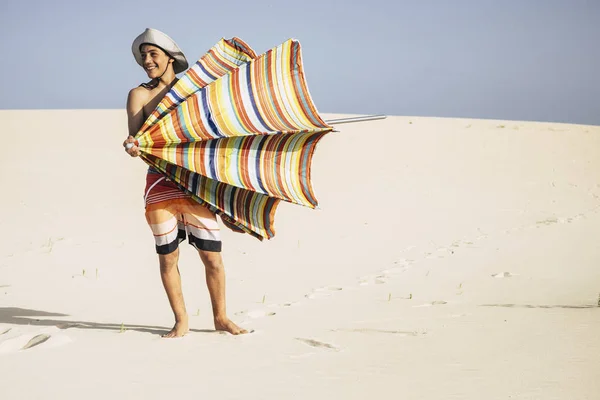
[0,110,600,400]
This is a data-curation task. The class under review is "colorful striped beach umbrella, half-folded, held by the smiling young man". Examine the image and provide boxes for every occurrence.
[136,38,333,240]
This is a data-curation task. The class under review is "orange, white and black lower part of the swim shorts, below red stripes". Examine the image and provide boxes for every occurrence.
[146,197,221,254]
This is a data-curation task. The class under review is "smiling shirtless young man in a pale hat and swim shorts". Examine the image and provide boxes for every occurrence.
[123,29,247,338]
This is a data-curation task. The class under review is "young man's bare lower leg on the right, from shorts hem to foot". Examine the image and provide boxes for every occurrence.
[198,250,248,335]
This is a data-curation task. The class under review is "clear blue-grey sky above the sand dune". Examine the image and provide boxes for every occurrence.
[0,0,600,125]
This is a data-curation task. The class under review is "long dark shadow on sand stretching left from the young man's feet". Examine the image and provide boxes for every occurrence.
[0,307,224,335]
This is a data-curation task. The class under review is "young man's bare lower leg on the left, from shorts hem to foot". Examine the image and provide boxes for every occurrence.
[158,248,189,338]
